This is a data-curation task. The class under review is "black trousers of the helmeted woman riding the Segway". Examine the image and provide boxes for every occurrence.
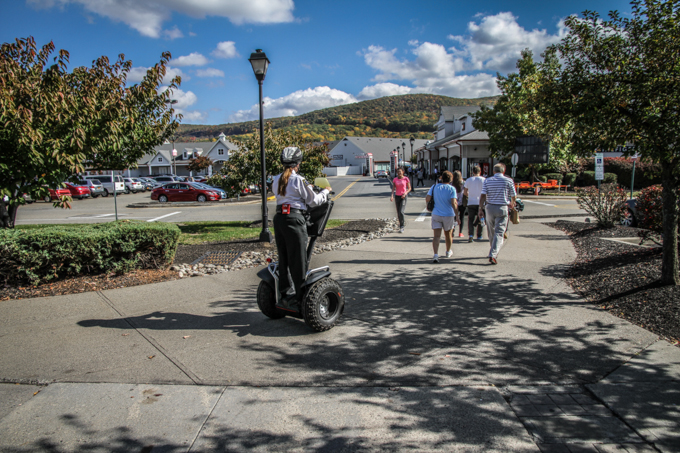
[274,213,307,300]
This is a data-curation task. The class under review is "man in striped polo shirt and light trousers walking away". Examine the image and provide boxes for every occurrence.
[479,163,517,264]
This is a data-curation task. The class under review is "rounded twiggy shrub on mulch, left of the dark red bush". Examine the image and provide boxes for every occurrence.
[576,184,628,228]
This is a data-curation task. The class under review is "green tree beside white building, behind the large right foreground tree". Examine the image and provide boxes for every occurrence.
[472,49,576,179]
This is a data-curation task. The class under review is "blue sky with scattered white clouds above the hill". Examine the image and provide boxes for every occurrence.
[0,0,631,124]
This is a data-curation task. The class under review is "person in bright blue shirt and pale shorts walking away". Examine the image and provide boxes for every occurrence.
[425,171,458,263]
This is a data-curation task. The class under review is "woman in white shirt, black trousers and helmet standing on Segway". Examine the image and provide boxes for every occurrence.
[272,146,331,308]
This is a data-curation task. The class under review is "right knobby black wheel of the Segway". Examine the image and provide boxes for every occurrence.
[302,278,345,332]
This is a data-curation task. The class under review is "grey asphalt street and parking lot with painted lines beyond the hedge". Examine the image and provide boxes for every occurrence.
[16,176,587,225]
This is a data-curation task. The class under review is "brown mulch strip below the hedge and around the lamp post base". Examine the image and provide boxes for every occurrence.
[0,219,386,301]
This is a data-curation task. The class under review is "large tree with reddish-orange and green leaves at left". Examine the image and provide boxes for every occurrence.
[0,37,181,228]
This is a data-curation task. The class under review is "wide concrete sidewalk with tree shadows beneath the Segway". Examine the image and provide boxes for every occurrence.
[0,212,680,452]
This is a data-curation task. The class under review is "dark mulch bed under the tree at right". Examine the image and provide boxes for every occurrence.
[550,221,680,345]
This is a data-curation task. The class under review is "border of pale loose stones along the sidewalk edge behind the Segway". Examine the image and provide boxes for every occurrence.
[170,217,399,278]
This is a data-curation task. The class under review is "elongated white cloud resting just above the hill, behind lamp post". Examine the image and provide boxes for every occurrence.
[229,87,357,123]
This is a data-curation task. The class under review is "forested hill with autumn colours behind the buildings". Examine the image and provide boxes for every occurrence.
[177,94,497,141]
